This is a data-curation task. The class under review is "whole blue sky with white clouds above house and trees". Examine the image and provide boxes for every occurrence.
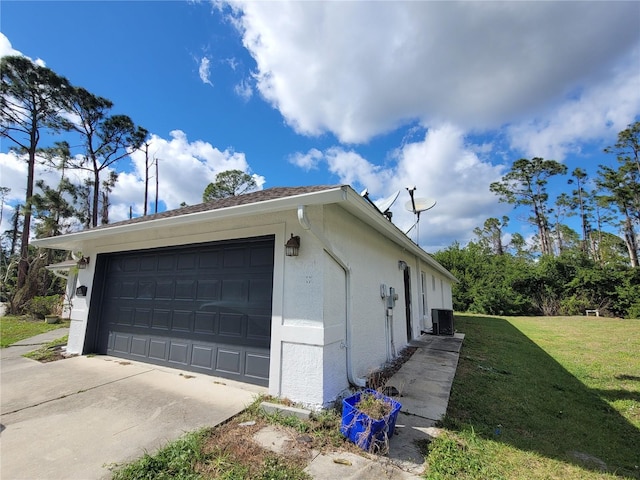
[0,0,640,250]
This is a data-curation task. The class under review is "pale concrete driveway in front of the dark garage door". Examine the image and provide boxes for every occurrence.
[0,335,267,480]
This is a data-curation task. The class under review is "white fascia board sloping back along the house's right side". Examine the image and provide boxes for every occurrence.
[346,189,458,283]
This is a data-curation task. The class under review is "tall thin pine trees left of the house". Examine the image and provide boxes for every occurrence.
[0,56,154,312]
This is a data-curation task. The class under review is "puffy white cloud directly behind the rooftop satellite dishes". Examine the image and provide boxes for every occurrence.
[291,125,509,250]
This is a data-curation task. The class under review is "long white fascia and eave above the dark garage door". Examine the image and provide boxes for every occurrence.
[31,186,347,251]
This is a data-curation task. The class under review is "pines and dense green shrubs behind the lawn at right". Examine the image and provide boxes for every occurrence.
[434,122,640,318]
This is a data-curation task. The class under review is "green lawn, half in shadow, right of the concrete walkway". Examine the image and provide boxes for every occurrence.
[427,315,640,480]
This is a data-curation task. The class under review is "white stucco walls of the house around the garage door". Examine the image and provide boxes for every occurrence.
[58,201,451,406]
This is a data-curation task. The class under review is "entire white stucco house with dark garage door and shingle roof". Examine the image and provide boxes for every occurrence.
[33,186,455,406]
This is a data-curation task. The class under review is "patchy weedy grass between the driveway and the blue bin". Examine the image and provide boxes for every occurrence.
[113,397,350,480]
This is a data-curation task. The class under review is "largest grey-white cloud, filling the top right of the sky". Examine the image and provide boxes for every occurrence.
[226,2,640,142]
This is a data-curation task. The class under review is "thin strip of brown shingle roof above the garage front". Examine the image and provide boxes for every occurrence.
[92,185,339,230]
